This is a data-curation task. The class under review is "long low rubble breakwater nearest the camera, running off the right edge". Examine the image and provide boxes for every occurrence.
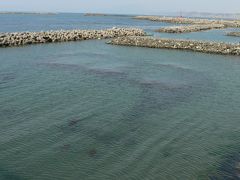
[108,36,240,56]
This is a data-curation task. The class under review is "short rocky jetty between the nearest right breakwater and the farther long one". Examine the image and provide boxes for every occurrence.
[156,24,225,33]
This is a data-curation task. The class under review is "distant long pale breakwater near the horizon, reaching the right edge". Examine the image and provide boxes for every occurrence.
[134,16,240,27]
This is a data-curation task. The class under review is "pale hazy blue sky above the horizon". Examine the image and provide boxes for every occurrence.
[0,0,240,14]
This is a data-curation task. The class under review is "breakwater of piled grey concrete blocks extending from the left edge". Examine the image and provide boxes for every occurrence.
[0,28,145,47]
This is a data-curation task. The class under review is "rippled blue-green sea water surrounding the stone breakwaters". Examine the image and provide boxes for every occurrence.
[0,14,240,180]
